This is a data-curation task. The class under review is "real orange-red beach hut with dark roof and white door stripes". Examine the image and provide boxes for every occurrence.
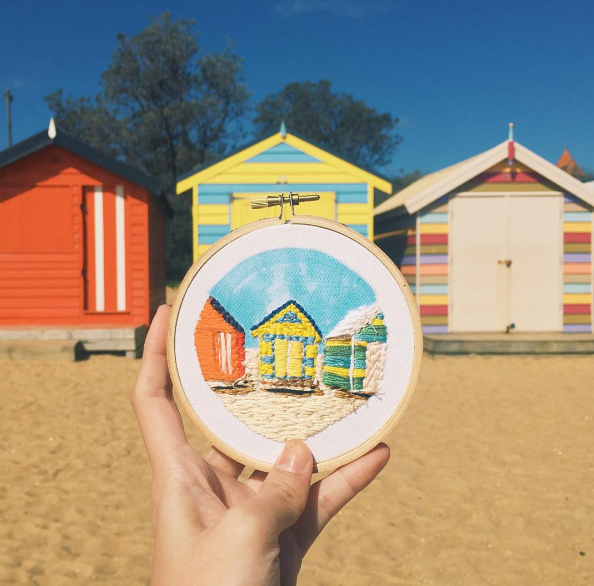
[0,126,165,349]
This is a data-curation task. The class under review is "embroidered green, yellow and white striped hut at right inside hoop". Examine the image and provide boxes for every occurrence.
[322,304,387,395]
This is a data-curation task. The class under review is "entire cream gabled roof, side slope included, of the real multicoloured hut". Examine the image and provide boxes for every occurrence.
[374,141,594,216]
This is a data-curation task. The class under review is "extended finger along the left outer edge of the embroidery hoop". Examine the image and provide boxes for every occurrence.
[132,305,188,471]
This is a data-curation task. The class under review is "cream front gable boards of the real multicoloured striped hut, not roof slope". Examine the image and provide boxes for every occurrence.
[400,141,594,214]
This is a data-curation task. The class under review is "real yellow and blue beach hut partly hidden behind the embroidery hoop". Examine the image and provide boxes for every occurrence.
[177,124,392,260]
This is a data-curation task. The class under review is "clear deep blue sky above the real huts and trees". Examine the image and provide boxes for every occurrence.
[0,0,594,173]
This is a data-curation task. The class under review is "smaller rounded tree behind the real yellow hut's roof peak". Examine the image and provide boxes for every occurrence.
[254,81,402,167]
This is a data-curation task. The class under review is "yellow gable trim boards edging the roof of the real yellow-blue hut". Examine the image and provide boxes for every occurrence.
[177,132,392,194]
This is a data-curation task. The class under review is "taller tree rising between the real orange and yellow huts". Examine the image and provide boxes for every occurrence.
[46,12,249,279]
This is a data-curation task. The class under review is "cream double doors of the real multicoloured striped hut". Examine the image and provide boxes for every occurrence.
[450,195,563,332]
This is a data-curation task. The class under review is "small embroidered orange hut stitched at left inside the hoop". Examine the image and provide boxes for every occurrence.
[194,297,245,381]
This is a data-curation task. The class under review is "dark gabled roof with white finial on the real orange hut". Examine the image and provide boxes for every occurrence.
[0,124,171,214]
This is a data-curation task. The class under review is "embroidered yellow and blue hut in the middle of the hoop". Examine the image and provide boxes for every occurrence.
[251,300,322,392]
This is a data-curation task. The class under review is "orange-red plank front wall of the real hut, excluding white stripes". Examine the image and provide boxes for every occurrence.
[0,145,155,325]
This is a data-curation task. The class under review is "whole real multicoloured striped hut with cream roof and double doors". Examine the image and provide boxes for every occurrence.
[375,133,594,334]
